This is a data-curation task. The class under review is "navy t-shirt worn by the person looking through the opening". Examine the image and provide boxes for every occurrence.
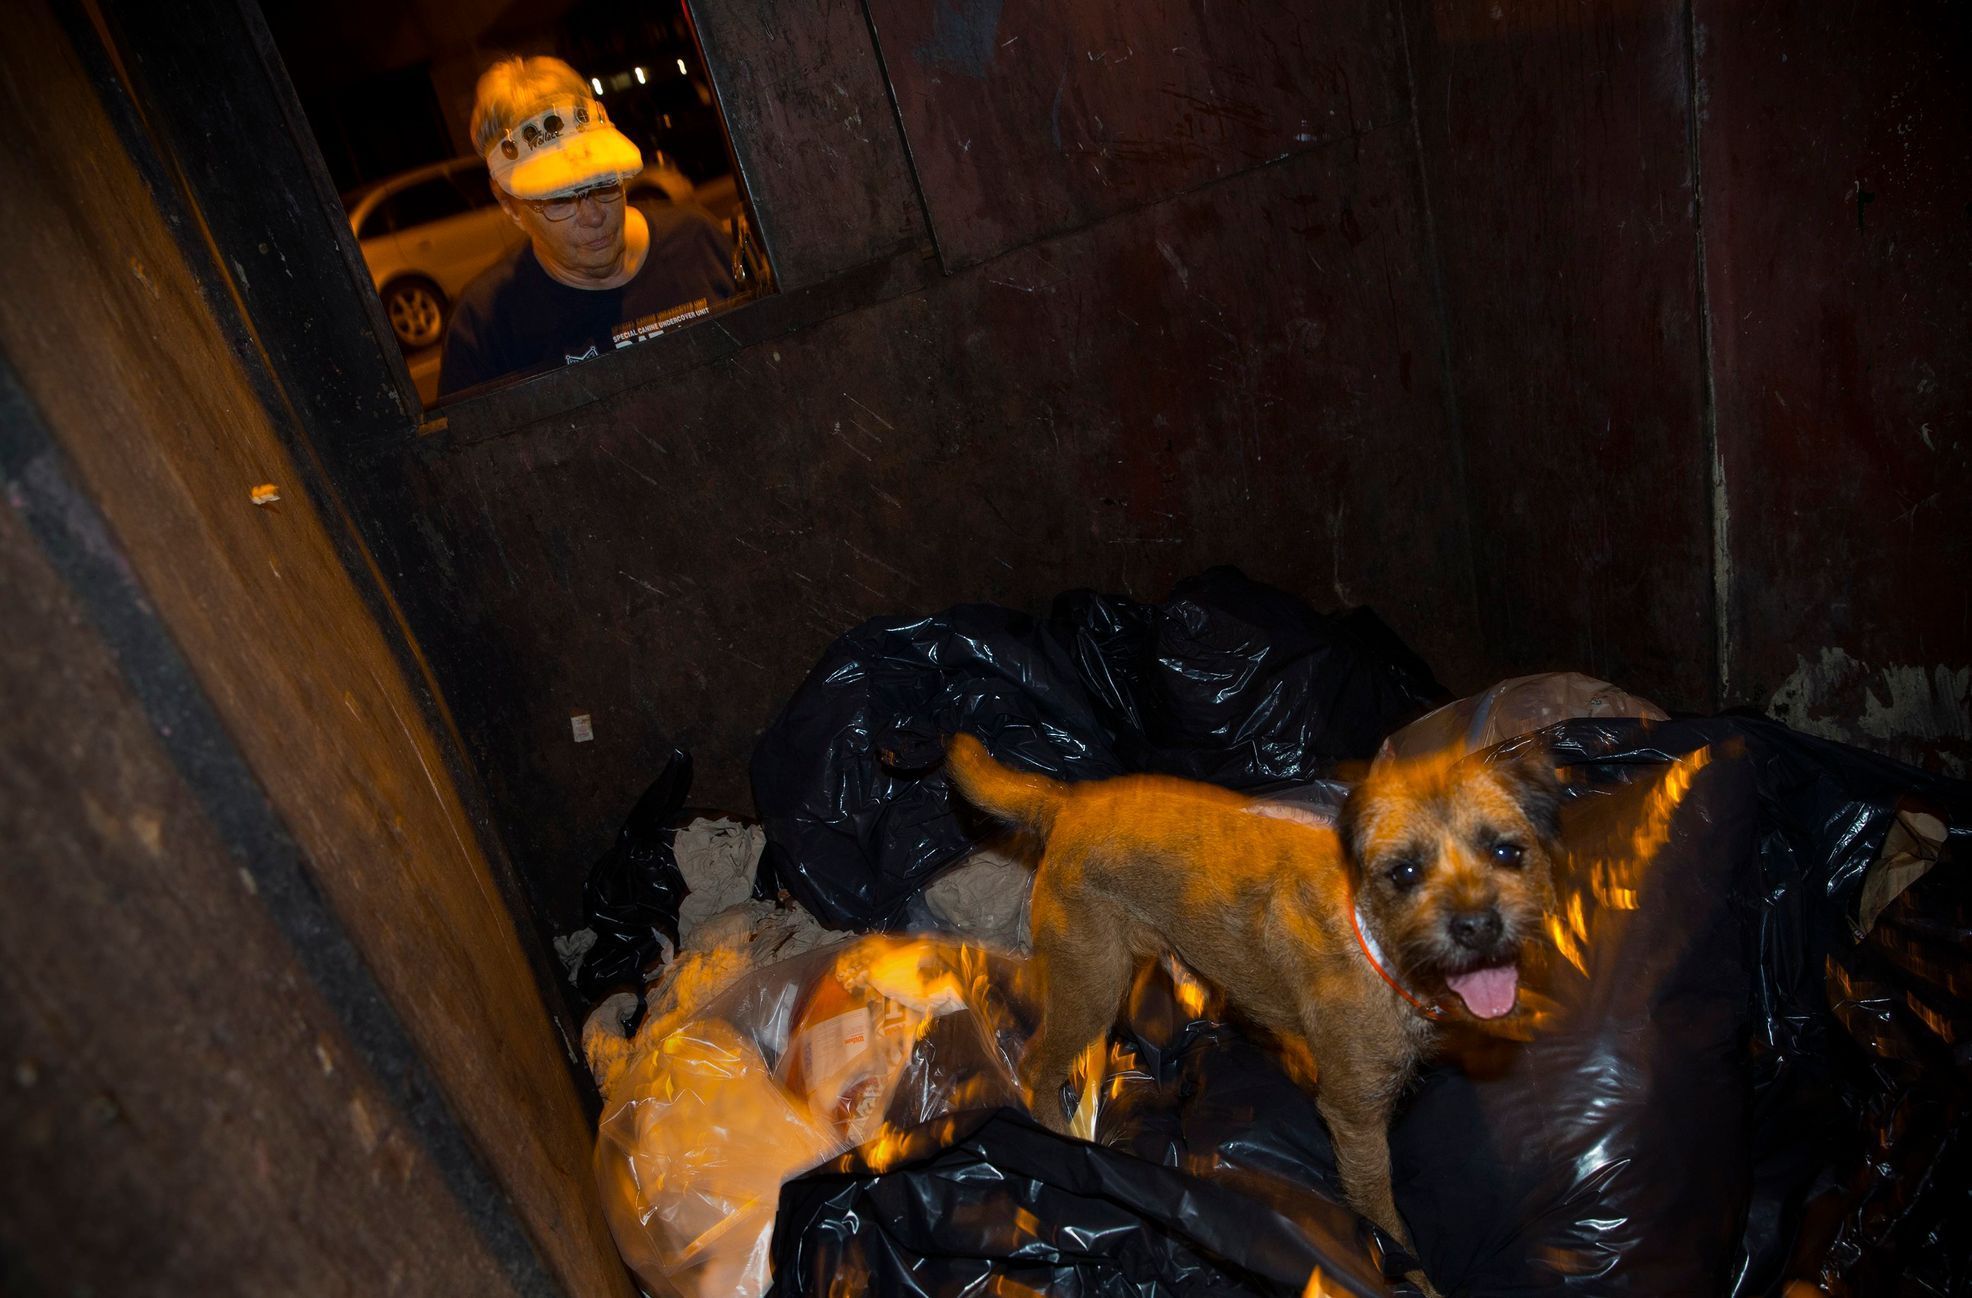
[438,199,734,397]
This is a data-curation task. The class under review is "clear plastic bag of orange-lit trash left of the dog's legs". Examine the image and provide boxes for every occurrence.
[596,937,1025,1298]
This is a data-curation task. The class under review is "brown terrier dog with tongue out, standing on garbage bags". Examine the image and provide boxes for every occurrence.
[947,734,1560,1247]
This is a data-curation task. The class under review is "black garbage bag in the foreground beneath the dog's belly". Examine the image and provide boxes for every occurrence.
[773,950,1416,1298]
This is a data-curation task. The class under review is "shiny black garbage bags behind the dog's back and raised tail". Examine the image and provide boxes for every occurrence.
[751,568,1444,927]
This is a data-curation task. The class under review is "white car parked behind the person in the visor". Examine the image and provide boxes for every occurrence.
[349,156,692,351]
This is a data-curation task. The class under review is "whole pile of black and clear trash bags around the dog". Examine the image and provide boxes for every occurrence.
[576,570,1972,1298]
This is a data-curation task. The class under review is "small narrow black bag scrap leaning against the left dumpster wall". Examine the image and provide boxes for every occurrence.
[576,750,692,1002]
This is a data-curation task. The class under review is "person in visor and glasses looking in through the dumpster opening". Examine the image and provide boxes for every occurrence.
[438,57,736,397]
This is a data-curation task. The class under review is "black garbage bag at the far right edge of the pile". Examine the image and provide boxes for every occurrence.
[1560,718,1972,1298]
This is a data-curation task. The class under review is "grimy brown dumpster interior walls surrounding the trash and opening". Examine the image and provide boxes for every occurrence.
[0,0,1972,1294]
